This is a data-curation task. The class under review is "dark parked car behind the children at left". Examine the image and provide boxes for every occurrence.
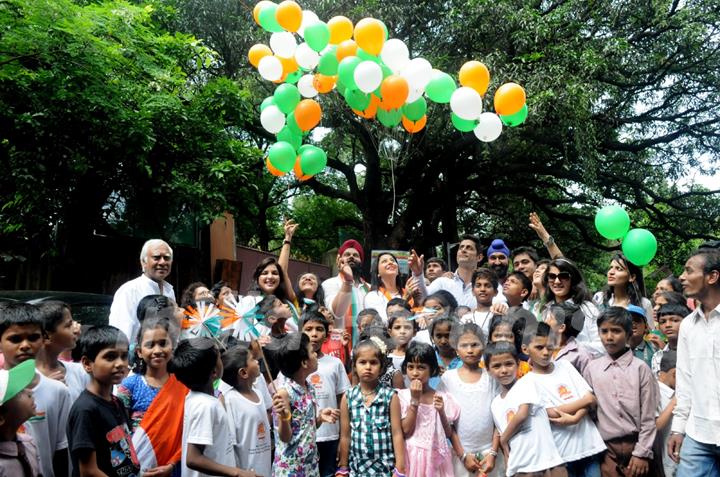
[0,290,113,325]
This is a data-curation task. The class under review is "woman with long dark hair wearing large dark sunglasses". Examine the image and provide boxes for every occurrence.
[543,258,605,356]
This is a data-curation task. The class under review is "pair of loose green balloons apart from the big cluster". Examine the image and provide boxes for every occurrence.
[595,205,657,267]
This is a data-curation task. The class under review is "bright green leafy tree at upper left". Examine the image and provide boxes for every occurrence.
[0,0,259,282]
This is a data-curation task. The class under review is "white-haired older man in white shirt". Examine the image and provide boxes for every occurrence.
[110,239,175,343]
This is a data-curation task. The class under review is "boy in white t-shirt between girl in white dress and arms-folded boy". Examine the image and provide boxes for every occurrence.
[484,342,567,477]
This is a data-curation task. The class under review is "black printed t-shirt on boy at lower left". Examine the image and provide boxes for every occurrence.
[67,390,140,477]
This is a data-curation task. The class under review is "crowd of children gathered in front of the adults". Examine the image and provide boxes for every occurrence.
[0,242,716,477]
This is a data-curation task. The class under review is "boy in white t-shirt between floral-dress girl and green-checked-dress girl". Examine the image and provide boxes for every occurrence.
[300,311,350,477]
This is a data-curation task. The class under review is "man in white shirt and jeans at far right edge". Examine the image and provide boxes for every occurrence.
[667,248,720,477]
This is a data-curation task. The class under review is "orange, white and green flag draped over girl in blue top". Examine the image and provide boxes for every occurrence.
[133,374,189,470]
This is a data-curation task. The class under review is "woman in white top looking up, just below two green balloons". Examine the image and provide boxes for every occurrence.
[593,253,655,330]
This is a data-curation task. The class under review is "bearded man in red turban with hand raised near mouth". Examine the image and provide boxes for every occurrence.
[322,239,370,342]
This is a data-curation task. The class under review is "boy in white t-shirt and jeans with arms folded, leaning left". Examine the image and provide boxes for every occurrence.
[518,323,606,477]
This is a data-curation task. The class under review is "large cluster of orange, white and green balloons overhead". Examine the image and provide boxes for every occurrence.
[248,0,528,180]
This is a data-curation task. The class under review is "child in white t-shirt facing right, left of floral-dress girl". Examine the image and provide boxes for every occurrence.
[222,344,272,477]
